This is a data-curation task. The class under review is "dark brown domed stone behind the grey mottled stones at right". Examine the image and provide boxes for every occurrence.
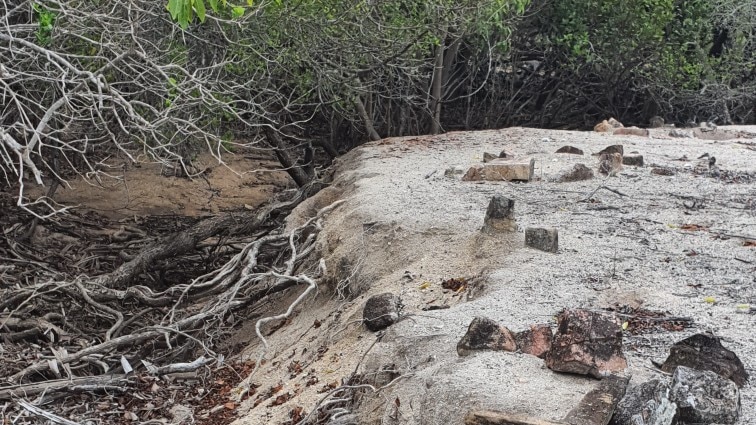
[661,334,748,388]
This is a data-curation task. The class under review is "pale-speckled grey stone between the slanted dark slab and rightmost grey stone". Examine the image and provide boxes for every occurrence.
[609,379,677,425]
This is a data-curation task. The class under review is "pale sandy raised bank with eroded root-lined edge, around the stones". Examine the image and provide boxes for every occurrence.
[236,127,756,425]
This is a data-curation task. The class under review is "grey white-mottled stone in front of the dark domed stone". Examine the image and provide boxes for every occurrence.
[670,366,740,424]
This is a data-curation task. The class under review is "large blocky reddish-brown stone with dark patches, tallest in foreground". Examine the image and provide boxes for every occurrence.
[546,309,627,378]
